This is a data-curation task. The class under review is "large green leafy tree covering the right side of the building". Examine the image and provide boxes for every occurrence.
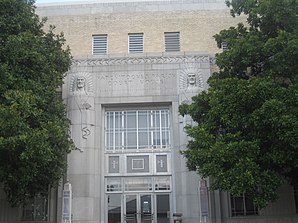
[180,0,298,208]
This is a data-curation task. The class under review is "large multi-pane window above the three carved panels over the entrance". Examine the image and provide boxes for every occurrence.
[105,110,170,150]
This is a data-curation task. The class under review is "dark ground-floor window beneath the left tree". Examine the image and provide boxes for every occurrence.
[22,196,48,221]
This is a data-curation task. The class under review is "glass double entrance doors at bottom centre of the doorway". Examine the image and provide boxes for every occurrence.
[124,194,153,223]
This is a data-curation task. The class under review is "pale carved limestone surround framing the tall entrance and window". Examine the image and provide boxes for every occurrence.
[63,53,212,222]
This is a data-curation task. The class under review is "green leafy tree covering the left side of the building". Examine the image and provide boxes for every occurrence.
[0,0,73,205]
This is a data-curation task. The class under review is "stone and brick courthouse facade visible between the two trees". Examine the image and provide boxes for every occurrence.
[0,0,298,223]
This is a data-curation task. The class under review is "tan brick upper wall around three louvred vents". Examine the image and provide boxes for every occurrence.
[37,0,243,57]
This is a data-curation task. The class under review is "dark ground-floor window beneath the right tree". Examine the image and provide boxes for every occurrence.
[231,194,259,216]
